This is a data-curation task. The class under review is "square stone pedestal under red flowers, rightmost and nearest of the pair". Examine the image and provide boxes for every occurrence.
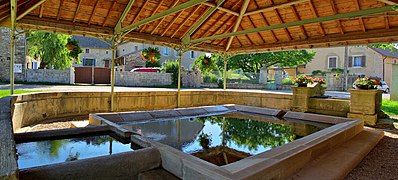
[347,89,383,125]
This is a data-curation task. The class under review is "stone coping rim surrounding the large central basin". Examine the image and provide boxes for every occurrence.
[90,105,363,179]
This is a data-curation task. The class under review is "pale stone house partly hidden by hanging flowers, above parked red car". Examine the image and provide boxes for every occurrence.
[116,42,205,69]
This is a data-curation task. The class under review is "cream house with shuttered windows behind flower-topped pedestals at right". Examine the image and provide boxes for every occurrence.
[302,46,398,85]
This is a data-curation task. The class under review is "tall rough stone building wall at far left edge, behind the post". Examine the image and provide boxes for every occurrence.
[0,28,26,81]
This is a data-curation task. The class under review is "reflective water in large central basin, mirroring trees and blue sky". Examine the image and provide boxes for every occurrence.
[125,116,321,155]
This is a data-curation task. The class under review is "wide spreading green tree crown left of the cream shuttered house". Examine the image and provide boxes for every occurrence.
[227,50,315,73]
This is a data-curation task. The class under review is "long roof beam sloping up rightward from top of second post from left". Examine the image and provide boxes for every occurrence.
[121,0,208,33]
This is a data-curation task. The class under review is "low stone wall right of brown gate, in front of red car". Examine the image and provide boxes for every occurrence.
[115,71,173,87]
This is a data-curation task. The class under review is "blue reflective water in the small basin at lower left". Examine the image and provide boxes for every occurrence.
[16,135,132,168]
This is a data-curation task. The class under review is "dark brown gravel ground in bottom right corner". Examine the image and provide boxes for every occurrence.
[346,131,398,180]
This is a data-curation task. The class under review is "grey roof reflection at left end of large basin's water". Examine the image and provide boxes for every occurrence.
[127,119,204,147]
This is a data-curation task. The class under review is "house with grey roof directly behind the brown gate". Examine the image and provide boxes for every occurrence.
[72,36,112,67]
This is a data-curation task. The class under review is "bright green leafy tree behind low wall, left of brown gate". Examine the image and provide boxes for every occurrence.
[27,31,83,69]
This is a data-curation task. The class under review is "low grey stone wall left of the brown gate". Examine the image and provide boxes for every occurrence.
[26,69,74,84]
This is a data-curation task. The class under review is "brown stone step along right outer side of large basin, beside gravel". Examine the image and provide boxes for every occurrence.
[288,129,384,180]
